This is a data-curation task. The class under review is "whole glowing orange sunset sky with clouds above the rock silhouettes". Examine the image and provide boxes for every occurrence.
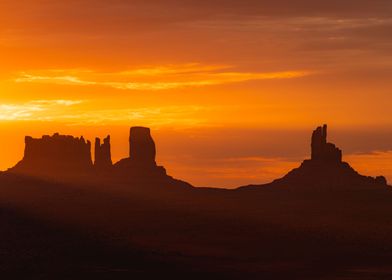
[0,0,392,187]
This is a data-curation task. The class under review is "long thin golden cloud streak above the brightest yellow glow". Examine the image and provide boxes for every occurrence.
[14,63,311,91]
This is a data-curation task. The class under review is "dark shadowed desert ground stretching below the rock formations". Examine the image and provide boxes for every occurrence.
[0,174,392,279]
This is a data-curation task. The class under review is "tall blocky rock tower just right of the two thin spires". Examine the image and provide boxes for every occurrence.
[129,127,156,166]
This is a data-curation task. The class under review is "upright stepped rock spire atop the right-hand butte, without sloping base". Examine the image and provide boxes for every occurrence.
[312,125,342,163]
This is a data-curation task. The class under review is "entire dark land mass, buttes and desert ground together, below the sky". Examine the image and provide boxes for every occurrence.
[0,126,392,280]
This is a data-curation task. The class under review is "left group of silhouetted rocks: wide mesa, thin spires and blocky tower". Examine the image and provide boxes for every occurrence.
[9,127,172,182]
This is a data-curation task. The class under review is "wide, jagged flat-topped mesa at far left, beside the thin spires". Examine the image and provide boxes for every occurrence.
[10,133,93,177]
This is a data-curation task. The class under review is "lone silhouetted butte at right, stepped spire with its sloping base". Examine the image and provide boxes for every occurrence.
[256,125,387,190]
